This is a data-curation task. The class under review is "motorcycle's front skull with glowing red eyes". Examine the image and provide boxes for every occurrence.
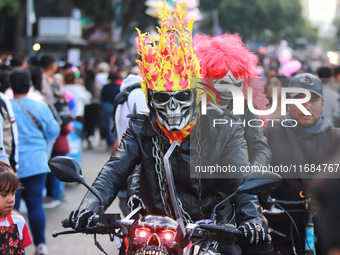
[128,215,183,255]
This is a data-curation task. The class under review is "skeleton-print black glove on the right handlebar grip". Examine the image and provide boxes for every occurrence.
[238,222,271,245]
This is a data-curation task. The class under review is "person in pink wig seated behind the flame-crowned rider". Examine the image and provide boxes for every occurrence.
[194,34,271,169]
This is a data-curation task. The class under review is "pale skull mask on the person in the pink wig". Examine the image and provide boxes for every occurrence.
[213,70,243,105]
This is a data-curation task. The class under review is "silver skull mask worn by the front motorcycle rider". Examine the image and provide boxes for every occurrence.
[151,90,196,131]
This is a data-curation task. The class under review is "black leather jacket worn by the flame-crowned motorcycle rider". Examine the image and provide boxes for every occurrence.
[79,108,266,227]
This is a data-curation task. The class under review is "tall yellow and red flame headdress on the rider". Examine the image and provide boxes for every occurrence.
[136,1,201,97]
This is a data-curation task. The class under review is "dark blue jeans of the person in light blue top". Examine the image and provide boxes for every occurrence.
[14,174,47,245]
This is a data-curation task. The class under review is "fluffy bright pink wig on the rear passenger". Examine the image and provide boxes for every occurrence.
[194,34,268,110]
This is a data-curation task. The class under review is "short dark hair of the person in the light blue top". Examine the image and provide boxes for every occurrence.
[9,68,31,94]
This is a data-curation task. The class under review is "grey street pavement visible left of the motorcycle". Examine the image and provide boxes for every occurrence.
[23,141,121,255]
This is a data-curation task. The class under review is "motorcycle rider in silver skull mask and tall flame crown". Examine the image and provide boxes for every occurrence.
[70,4,271,254]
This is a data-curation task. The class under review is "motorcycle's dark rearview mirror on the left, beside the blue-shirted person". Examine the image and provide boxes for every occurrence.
[48,156,84,184]
